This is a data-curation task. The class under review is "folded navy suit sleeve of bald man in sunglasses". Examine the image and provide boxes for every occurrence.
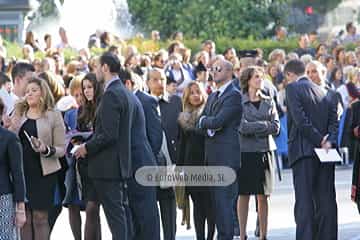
[200,92,242,129]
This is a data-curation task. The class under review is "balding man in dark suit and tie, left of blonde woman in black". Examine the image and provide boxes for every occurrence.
[147,69,182,240]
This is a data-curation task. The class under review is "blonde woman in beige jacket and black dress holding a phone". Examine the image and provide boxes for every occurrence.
[10,78,65,240]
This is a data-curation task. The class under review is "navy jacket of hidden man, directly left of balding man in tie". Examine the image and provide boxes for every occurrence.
[135,91,162,156]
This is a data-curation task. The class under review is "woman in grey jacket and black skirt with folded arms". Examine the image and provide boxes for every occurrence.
[238,67,280,240]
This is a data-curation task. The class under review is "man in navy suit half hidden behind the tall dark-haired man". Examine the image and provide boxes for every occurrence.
[119,69,161,240]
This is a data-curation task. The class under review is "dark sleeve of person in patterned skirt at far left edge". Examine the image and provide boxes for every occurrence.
[8,135,25,202]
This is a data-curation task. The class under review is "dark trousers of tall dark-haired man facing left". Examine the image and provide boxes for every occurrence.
[93,179,130,240]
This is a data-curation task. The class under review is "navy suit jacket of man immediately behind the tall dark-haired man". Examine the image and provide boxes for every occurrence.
[131,96,156,174]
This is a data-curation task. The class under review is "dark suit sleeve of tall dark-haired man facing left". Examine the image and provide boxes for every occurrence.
[85,91,121,156]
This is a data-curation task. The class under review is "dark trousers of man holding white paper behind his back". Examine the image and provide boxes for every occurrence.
[292,157,338,240]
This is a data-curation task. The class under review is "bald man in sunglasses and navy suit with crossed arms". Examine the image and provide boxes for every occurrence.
[199,60,242,240]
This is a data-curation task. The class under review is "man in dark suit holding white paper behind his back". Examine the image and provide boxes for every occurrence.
[284,60,338,240]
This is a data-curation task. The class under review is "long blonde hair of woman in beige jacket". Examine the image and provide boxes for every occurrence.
[15,77,55,116]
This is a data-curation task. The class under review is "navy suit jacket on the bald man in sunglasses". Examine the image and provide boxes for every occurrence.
[200,84,242,169]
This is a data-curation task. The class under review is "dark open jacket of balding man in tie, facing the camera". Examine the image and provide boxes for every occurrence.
[159,95,182,163]
